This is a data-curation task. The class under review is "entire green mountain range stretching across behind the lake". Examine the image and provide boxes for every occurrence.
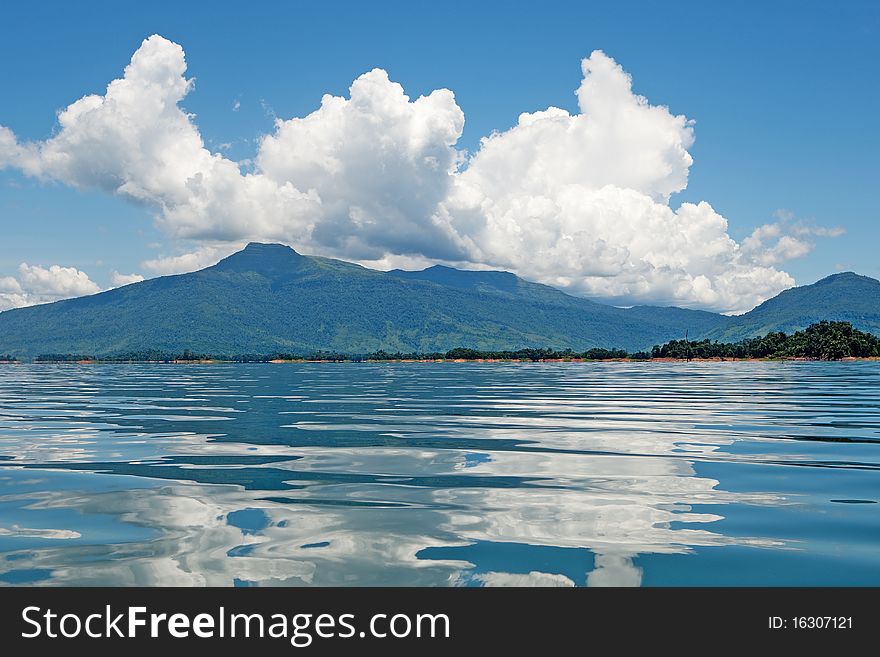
[0,243,880,358]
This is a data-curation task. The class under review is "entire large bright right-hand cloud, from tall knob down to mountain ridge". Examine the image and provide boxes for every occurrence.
[444,51,794,311]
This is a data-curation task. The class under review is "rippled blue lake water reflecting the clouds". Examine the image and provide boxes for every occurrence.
[0,362,880,586]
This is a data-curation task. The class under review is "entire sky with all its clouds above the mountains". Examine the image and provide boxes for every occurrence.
[0,0,880,312]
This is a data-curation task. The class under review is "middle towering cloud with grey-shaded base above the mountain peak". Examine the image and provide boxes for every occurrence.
[256,69,464,258]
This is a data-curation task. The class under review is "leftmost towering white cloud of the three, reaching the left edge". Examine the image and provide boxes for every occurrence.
[0,36,319,239]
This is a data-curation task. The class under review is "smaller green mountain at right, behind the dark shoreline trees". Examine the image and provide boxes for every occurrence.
[705,272,880,342]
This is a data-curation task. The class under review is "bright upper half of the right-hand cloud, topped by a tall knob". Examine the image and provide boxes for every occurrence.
[454,51,694,206]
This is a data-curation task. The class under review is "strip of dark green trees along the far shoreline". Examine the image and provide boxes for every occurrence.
[10,321,880,363]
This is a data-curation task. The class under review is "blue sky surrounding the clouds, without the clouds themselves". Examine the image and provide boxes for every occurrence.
[0,2,880,309]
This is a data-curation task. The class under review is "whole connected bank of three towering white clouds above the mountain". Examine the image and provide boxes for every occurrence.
[0,36,829,311]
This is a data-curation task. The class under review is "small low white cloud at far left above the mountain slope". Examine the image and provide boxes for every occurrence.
[0,262,101,310]
